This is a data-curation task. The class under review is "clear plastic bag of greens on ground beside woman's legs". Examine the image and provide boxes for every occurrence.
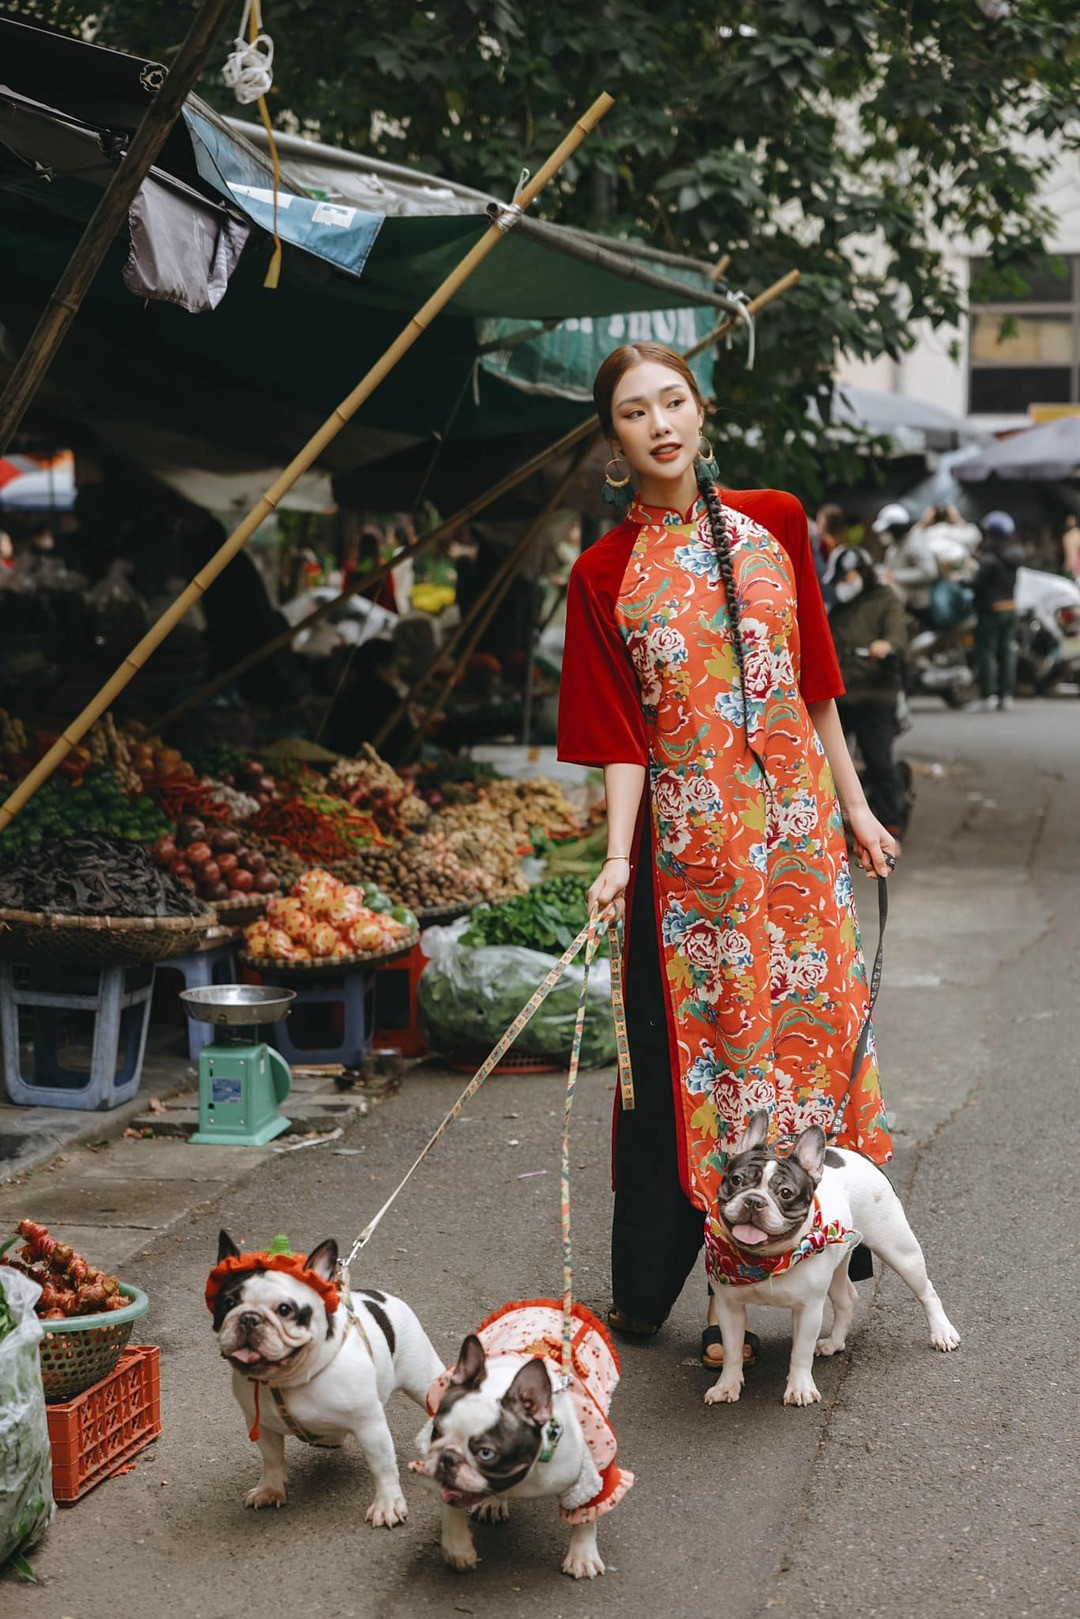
[418,916,615,1069]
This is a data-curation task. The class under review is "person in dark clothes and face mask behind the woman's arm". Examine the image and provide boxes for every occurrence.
[829,546,907,835]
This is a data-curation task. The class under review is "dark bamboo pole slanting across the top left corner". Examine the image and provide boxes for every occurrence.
[0,0,232,455]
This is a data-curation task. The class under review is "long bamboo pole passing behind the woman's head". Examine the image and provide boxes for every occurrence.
[151,270,800,732]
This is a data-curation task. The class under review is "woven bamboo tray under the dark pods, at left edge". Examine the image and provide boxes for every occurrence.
[0,905,215,967]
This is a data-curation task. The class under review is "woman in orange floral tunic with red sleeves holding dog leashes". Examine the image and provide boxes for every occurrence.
[559,343,897,1365]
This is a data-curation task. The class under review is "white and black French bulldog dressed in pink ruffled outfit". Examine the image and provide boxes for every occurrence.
[408,1332,604,1580]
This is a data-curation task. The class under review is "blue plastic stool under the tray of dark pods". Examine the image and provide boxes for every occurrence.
[0,962,154,1111]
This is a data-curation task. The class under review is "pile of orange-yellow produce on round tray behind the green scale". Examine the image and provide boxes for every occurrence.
[244,868,416,962]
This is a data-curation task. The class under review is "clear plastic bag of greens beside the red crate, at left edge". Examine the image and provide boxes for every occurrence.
[0,1264,57,1566]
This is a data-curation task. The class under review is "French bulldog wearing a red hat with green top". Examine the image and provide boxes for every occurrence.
[212,1232,442,1528]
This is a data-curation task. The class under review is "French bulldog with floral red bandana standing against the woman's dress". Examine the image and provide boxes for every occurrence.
[704,1111,960,1405]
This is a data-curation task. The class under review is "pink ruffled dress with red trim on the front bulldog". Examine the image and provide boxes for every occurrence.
[427,1298,633,1523]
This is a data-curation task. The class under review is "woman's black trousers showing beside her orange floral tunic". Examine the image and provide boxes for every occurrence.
[612,818,704,1326]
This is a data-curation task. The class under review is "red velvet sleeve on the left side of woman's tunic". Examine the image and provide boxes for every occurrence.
[559,526,649,766]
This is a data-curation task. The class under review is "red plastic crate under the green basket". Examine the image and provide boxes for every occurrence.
[47,1344,162,1506]
